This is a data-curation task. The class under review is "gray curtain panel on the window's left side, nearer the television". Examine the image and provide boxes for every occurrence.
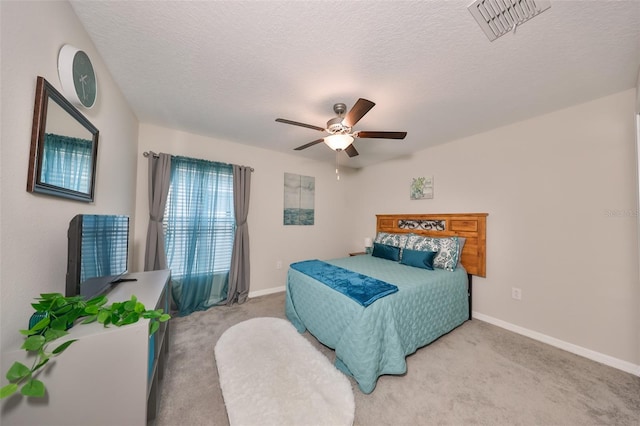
[144,152,171,271]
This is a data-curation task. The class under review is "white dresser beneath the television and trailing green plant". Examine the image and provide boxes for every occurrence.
[0,270,170,426]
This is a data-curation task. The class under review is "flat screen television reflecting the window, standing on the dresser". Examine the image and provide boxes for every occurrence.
[66,214,129,300]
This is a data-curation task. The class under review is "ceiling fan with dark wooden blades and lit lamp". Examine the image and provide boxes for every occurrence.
[276,98,407,157]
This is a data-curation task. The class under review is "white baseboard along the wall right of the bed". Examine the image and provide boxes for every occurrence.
[472,311,640,376]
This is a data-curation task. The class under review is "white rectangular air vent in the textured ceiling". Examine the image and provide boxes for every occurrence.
[468,0,551,41]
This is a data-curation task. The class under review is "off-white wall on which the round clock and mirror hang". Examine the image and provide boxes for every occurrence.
[0,1,138,351]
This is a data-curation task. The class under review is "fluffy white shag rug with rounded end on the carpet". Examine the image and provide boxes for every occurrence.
[215,318,355,426]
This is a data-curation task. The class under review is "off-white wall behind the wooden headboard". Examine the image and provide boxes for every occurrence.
[349,90,640,374]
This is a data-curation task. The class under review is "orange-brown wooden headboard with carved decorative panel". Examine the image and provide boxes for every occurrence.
[376,213,488,277]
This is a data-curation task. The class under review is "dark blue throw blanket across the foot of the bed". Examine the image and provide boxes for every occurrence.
[291,260,398,307]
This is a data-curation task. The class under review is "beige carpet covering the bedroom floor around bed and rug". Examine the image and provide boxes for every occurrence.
[156,293,640,426]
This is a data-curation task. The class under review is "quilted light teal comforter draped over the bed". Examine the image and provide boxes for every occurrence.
[286,256,469,393]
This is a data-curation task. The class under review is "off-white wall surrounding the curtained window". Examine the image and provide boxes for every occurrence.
[134,124,352,295]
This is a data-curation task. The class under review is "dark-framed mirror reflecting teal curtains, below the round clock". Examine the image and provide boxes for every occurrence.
[27,77,99,202]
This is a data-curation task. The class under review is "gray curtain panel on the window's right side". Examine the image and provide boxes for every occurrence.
[227,165,251,305]
